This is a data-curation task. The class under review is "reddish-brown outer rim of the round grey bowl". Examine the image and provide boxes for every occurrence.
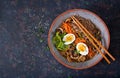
[48,9,110,70]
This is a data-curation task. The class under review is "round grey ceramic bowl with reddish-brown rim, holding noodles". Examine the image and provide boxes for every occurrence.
[48,9,110,69]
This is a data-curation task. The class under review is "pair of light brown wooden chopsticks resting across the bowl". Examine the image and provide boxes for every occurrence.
[71,16,115,64]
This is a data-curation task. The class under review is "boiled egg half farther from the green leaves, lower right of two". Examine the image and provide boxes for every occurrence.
[76,42,89,55]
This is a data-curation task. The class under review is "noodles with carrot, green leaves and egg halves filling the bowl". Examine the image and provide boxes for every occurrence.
[52,15,102,62]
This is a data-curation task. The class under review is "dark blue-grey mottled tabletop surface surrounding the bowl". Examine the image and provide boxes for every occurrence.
[0,0,120,78]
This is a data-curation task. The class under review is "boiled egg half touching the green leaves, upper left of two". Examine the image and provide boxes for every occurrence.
[63,33,75,45]
